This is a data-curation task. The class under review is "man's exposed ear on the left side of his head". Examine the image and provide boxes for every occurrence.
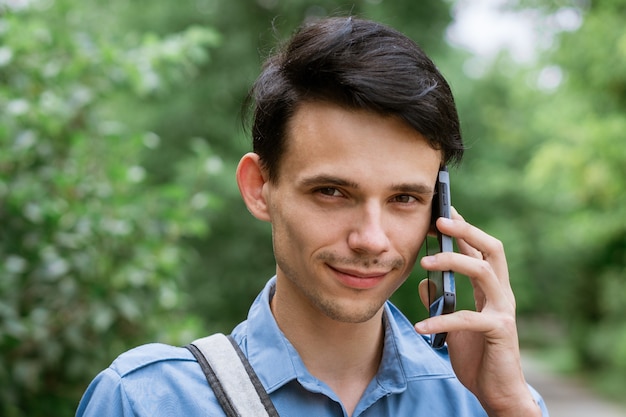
[237,152,270,221]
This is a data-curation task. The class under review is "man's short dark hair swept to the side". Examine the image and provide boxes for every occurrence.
[248,17,464,181]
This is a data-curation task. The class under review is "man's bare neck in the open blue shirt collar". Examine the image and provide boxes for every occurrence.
[271,276,384,415]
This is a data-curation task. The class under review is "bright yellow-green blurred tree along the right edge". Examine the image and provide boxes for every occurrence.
[526,0,626,395]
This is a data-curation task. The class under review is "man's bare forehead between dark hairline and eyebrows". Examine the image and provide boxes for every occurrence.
[279,102,442,182]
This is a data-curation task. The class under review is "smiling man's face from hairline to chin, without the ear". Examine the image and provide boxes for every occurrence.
[263,103,441,323]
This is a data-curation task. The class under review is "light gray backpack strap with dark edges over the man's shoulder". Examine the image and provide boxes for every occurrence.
[185,333,279,417]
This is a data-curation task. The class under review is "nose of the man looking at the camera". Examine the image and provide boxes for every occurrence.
[348,203,390,255]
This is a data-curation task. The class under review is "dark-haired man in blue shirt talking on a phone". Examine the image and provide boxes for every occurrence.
[77,18,547,417]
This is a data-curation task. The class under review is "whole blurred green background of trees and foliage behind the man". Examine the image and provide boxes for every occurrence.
[0,0,626,417]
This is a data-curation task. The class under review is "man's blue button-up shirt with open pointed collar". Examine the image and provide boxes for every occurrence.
[76,279,548,417]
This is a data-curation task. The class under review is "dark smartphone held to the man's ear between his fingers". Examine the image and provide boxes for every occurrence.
[426,166,456,349]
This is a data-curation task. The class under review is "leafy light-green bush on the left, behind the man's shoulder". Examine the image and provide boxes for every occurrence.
[0,1,221,416]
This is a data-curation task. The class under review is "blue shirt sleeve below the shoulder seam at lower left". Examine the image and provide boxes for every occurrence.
[76,368,135,417]
